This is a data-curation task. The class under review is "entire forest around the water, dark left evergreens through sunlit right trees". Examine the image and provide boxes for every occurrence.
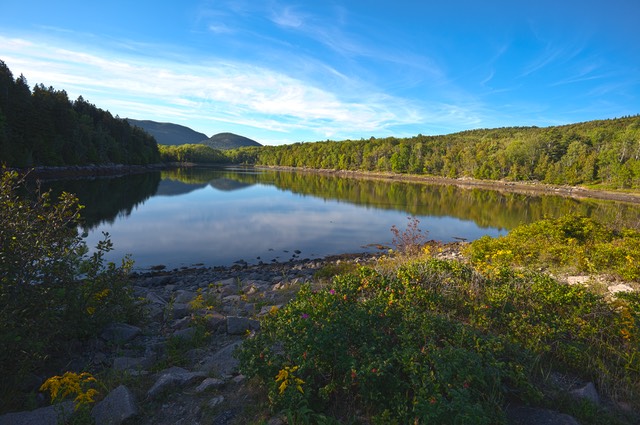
[0,56,640,189]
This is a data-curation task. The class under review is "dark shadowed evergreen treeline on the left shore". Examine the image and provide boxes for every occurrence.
[0,60,160,168]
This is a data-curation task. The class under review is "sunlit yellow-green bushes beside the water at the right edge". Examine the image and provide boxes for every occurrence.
[468,215,640,280]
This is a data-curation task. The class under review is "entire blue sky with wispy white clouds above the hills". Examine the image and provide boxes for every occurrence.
[0,0,640,145]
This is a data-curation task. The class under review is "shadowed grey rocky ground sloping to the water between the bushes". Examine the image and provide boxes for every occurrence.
[0,243,636,425]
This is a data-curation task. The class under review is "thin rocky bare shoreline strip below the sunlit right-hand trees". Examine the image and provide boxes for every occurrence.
[255,165,640,204]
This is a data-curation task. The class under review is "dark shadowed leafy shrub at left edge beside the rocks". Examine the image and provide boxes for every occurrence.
[0,172,140,410]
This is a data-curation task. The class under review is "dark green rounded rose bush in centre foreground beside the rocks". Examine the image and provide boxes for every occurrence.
[240,269,536,424]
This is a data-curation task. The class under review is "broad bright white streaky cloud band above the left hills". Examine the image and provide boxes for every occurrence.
[0,32,448,141]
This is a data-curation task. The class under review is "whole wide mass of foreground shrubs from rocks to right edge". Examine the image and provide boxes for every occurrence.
[239,259,640,424]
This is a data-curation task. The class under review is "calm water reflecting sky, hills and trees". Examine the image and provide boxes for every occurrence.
[43,168,640,268]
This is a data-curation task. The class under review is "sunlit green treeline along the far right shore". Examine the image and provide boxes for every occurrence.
[226,115,640,189]
